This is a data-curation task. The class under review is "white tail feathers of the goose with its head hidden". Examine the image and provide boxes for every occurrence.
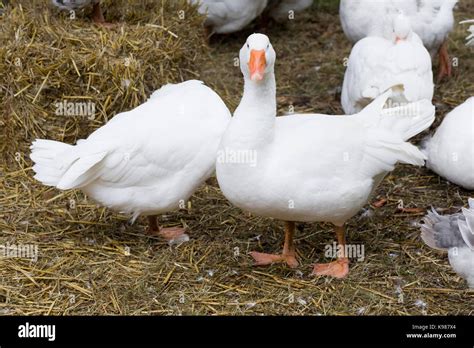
[30,139,107,190]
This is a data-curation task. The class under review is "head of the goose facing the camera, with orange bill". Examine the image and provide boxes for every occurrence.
[239,34,276,83]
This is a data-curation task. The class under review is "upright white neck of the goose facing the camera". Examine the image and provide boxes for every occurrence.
[232,71,276,149]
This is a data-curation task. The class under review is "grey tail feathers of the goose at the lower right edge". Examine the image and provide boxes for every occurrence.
[421,208,466,251]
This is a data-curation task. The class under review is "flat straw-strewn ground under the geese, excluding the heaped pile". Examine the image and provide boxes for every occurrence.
[0,0,474,315]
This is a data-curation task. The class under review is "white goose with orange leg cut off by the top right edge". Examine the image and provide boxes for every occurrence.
[339,0,458,80]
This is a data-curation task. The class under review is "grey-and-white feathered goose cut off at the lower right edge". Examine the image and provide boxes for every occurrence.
[421,198,474,288]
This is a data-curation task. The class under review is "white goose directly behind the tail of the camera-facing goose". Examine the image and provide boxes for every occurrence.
[341,14,434,115]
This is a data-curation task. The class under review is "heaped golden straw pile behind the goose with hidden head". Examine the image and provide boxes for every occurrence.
[0,0,206,164]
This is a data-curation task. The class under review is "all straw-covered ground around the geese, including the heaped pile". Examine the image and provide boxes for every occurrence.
[0,0,474,315]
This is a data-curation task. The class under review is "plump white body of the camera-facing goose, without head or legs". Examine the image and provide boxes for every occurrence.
[216,84,434,225]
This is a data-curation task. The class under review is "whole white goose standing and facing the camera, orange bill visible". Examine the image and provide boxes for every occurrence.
[216,34,434,277]
